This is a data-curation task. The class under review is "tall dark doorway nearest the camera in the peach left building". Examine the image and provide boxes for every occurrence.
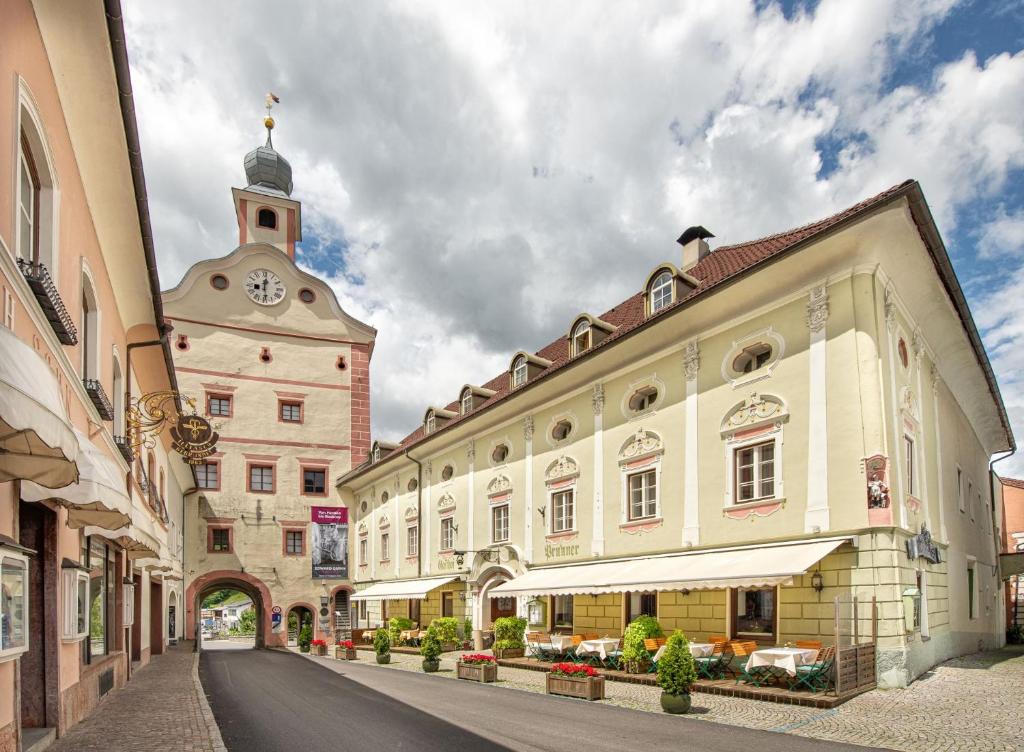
[18,502,58,728]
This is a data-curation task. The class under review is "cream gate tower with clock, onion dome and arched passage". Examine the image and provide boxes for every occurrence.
[163,116,376,646]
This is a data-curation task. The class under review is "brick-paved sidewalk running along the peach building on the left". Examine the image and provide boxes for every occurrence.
[49,643,226,752]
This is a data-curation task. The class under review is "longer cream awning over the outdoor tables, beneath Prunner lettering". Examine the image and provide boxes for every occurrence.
[490,538,849,597]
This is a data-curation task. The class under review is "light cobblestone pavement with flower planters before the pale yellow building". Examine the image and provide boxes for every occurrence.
[301,647,1024,752]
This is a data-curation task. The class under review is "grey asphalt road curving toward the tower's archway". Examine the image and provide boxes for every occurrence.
[200,650,868,752]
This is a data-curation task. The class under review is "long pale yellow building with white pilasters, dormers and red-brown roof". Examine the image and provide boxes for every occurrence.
[337,181,1014,686]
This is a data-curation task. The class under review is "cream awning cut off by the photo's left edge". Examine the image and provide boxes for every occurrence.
[0,326,78,488]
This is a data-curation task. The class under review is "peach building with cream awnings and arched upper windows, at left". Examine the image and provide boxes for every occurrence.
[0,0,188,751]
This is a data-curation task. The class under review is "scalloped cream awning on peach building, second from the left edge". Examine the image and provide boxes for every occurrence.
[22,428,131,530]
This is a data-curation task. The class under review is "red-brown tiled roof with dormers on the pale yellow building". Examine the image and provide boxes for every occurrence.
[348,180,991,483]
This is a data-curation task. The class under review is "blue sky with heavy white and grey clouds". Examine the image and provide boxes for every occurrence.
[124,0,1024,476]
